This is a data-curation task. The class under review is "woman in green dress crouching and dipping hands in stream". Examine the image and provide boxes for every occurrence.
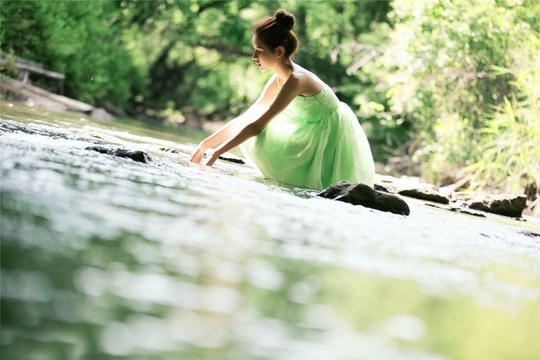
[191,9,374,189]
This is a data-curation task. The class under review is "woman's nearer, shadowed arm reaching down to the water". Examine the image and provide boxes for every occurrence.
[206,75,300,166]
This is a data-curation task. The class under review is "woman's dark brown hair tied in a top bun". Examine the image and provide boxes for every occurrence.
[252,9,298,58]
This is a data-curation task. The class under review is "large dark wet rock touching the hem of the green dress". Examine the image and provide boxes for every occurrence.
[317,181,411,215]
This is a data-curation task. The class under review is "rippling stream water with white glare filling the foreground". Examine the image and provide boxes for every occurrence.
[0,102,540,360]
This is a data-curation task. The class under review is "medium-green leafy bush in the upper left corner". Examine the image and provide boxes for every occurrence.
[0,0,144,107]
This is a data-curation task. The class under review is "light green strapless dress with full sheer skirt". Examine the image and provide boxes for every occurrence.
[240,83,374,189]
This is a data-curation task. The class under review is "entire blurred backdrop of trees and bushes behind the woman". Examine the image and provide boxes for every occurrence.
[0,0,540,193]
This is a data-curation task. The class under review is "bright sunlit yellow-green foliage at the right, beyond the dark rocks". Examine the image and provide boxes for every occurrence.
[366,0,540,190]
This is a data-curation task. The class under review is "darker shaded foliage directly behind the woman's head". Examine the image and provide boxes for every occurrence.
[118,1,389,120]
